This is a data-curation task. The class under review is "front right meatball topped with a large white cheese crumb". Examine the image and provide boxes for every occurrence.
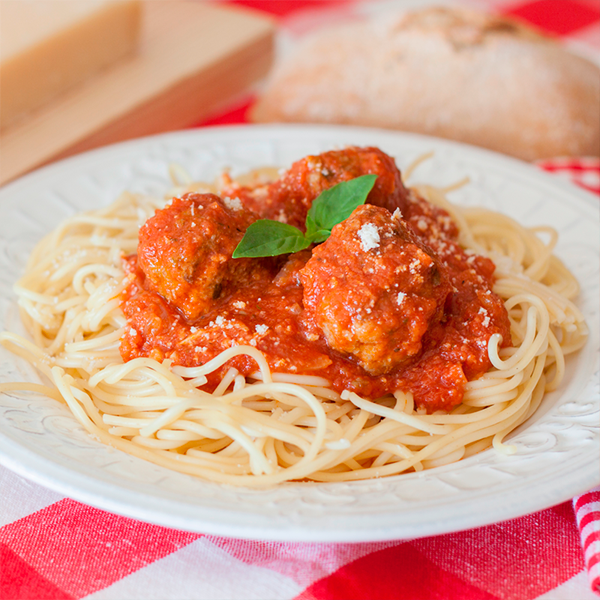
[300,205,451,375]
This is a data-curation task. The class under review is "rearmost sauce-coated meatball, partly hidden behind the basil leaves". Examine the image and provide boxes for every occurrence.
[224,147,408,231]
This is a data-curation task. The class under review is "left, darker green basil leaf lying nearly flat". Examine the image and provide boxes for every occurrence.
[233,219,310,258]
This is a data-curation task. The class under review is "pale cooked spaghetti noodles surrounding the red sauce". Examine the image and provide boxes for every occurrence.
[0,151,586,486]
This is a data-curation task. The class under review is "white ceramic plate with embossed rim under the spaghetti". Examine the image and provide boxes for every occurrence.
[0,126,600,542]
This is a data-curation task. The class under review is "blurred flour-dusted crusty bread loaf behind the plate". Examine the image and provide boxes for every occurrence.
[252,8,600,160]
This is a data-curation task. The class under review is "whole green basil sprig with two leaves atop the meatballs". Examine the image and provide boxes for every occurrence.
[233,175,377,258]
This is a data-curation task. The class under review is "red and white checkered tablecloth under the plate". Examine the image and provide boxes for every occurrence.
[0,0,600,600]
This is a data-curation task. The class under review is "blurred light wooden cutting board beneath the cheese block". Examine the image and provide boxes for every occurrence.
[0,0,275,184]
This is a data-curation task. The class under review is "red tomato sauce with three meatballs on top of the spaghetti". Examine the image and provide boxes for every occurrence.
[121,148,510,412]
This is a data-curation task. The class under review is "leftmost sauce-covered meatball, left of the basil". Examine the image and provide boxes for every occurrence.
[138,193,263,320]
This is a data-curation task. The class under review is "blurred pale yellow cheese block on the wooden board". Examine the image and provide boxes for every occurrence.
[0,0,141,129]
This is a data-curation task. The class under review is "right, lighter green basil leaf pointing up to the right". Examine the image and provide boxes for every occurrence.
[306,175,377,235]
